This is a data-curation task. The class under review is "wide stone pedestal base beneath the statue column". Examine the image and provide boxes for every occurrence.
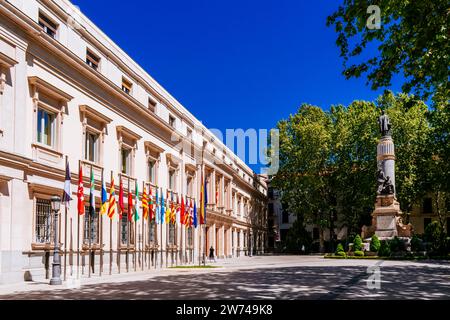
[362,194,412,239]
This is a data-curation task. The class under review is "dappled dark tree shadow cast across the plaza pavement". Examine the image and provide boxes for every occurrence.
[0,264,450,300]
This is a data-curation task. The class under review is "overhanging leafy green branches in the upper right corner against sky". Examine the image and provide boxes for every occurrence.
[327,0,450,101]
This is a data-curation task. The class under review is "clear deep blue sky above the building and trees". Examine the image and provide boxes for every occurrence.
[72,0,400,170]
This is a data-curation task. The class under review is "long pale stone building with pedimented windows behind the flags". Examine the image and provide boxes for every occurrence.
[0,0,267,284]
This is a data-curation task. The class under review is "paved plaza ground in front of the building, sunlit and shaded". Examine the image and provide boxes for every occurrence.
[0,256,450,300]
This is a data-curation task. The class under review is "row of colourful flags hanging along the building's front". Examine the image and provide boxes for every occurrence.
[62,162,208,228]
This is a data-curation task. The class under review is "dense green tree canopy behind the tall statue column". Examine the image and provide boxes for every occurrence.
[272,91,450,249]
